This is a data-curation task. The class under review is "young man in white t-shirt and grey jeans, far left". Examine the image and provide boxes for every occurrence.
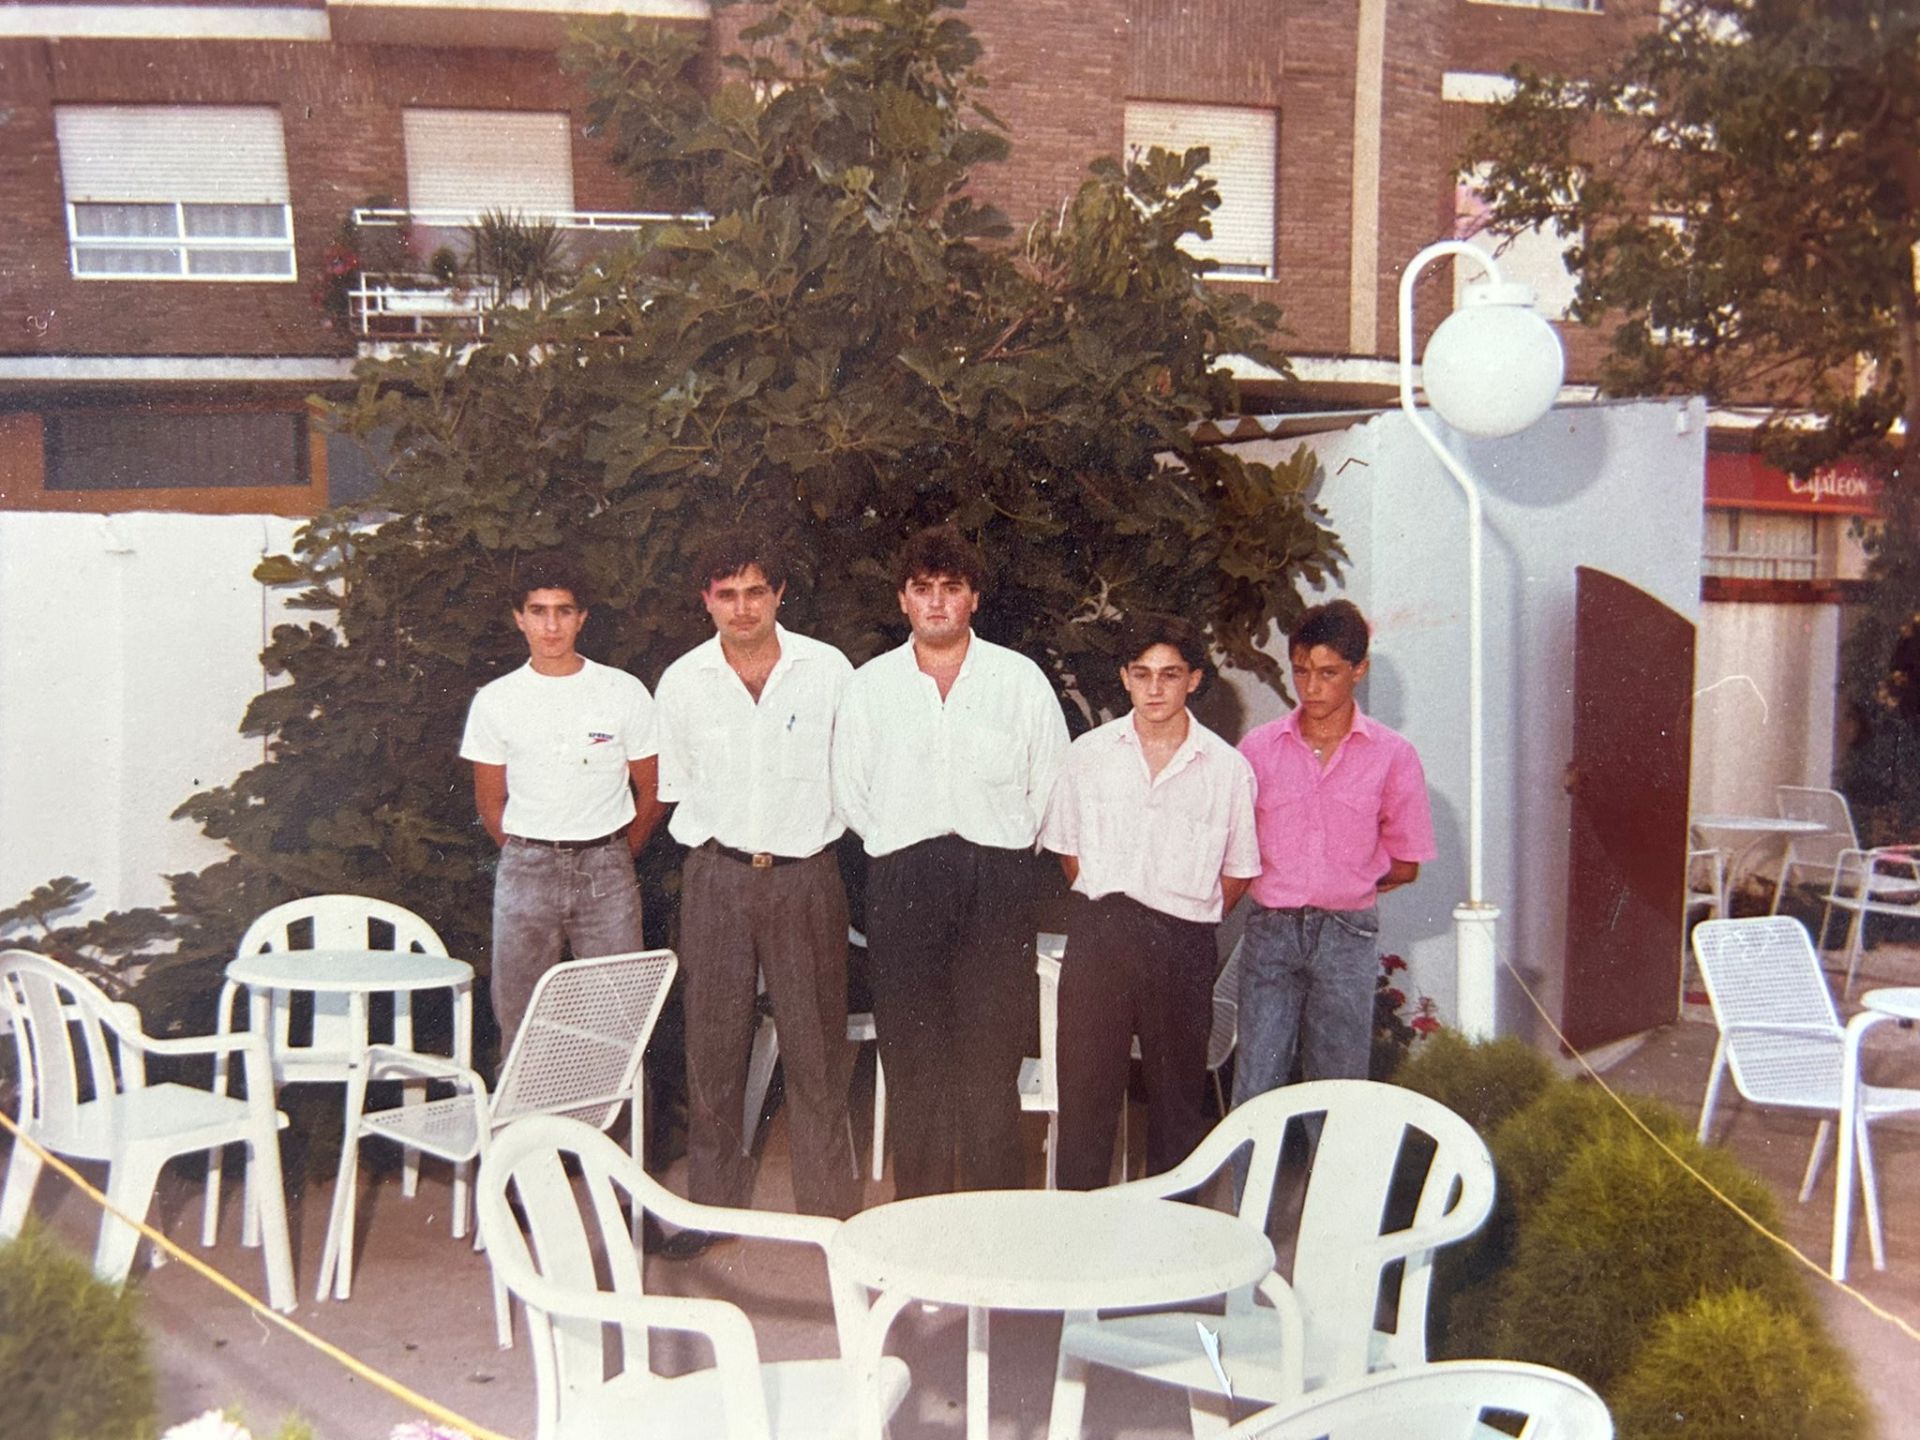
[461,557,662,1054]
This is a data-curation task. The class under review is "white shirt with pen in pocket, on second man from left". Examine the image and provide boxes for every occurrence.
[653,626,852,858]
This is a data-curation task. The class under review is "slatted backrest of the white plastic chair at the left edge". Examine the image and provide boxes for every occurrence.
[0,950,146,1150]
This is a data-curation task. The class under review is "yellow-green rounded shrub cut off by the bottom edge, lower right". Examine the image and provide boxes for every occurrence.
[1611,1290,1872,1440]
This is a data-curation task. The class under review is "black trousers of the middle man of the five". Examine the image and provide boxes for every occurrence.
[866,835,1039,1200]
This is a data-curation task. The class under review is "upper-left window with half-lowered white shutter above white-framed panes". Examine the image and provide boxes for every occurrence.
[54,106,294,280]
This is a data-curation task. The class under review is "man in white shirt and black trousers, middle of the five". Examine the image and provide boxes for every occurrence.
[833,526,1068,1198]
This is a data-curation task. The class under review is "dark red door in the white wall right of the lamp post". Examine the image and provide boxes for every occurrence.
[1561,566,1693,1050]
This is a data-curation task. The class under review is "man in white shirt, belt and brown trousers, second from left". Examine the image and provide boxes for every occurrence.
[657,534,860,1256]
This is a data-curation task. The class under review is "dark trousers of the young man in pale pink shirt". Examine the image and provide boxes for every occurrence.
[1056,895,1217,1190]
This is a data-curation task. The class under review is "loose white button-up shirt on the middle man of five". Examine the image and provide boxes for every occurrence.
[833,634,1068,856]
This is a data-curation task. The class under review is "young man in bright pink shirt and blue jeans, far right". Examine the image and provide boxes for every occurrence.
[1233,599,1434,1104]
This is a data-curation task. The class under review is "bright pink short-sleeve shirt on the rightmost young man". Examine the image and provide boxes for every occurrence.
[1240,707,1436,910]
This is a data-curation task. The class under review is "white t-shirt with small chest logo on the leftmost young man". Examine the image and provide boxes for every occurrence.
[461,657,655,841]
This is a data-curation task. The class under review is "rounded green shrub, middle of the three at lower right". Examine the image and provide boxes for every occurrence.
[1494,1127,1812,1390]
